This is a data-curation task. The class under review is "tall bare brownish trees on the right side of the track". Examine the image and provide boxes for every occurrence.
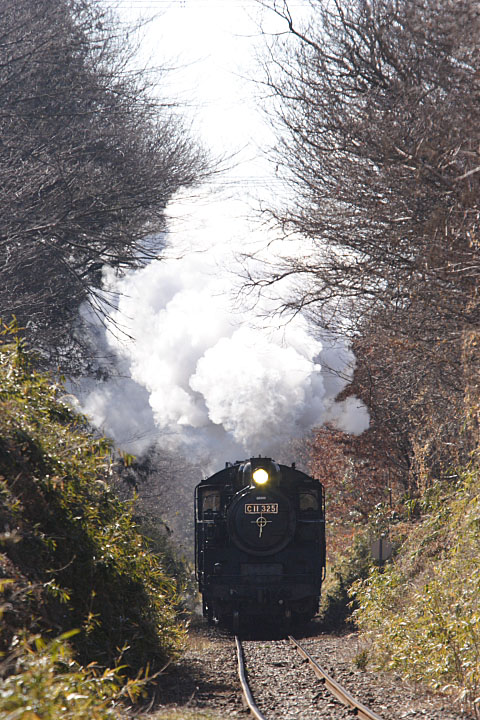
[251,0,480,490]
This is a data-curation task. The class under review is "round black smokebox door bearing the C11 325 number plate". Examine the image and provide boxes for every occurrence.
[228,488,295,555]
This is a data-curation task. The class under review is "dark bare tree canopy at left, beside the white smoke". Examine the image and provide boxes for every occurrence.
[0,0,207,368]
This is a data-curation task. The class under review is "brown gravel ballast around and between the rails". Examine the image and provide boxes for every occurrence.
[144,622,472,720]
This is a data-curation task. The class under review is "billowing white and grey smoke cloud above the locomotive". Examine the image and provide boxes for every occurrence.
[75,194,368,465]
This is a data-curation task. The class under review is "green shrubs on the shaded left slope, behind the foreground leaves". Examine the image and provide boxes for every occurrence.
[0,328,184,676]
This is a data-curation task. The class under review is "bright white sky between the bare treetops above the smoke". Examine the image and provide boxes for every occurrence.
[111,0,296,200]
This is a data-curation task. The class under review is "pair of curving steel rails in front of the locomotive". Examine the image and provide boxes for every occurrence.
[235,636,382,720]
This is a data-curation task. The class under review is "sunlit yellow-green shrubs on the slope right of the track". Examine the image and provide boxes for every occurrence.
[353,469,480,706]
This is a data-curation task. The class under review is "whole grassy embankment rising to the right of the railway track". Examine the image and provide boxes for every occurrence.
[322,459,480,716]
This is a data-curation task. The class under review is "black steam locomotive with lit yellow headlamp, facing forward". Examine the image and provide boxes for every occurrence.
[195,457,325,630]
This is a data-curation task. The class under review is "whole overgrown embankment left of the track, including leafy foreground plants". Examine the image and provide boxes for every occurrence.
[0,328,184,720]
